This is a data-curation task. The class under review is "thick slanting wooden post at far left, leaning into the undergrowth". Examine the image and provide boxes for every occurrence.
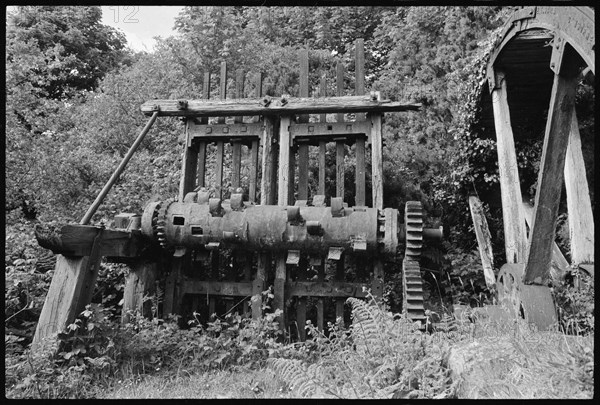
[32,229,102,348]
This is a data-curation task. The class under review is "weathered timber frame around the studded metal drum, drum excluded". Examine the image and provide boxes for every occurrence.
[34,39,424,345]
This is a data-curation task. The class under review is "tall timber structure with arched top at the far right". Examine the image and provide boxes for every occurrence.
[470,7,595,329]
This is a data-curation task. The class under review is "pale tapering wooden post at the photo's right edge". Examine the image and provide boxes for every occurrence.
[565,107,594,264]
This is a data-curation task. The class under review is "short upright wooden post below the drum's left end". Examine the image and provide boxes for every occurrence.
[121,261,158,323]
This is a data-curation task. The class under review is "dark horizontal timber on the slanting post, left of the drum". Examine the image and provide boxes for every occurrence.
[35,224,146,257]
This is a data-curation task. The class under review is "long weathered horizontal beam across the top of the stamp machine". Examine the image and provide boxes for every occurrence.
[140,96,421,117]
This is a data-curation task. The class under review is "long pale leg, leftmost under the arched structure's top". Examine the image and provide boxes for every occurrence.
[491,71,527,263]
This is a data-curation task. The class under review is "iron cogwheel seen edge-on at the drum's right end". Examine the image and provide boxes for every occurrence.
[402,201,425,322]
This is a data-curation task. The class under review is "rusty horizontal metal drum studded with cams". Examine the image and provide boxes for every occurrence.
[142,200,397,254]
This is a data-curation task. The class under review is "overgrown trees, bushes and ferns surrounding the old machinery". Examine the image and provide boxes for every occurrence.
[5,6,595,398]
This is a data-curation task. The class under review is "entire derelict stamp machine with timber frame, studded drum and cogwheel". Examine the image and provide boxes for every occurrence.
[34,40,442,344]
